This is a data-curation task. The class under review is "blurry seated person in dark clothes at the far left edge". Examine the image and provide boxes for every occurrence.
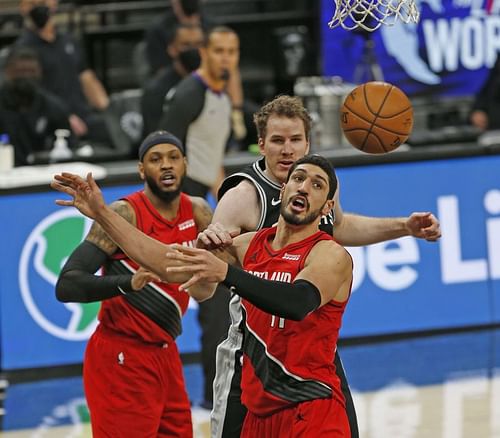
[0,47,73,166]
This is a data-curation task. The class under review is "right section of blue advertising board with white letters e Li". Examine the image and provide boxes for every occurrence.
[338,156,500,337]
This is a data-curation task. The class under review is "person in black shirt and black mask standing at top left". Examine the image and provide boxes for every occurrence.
[15,0,113,146]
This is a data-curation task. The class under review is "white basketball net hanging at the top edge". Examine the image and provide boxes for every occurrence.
[328,0,420,32]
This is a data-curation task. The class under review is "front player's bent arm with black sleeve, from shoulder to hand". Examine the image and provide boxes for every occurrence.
[167,233,352,314]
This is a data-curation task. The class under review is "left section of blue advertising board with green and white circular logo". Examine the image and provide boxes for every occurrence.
[0,185,200,369]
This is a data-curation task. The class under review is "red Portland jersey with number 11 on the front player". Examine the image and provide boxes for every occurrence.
[241,227,347,416]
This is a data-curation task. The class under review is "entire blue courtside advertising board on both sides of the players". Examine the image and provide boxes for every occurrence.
[0,156,500,369]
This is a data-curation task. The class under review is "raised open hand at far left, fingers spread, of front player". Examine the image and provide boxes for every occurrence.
[50,172,106,219]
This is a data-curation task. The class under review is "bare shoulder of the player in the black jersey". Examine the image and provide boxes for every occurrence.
[213,180,261,232]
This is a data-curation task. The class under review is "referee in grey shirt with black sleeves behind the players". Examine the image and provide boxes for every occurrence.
[160,26,239,408]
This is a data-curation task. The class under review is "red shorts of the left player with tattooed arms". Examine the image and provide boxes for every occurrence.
[83,326,193,438]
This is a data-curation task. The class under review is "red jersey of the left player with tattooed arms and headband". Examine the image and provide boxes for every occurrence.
[99,191,198,343]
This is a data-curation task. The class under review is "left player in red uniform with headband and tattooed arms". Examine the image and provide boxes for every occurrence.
[56,131,211,438]
